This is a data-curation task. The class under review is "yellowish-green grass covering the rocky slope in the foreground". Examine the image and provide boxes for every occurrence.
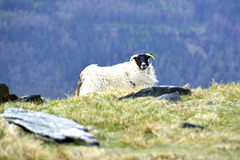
[0,83,240,160]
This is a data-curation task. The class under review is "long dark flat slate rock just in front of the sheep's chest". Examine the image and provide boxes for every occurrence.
[118,86,191,100]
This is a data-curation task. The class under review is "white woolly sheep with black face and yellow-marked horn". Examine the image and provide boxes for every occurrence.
[75,53,158,96]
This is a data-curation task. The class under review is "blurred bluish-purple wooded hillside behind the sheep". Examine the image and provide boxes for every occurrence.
[0,0,240,98]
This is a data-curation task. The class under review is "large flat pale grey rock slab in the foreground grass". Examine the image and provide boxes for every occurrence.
[1,108,99,146]
